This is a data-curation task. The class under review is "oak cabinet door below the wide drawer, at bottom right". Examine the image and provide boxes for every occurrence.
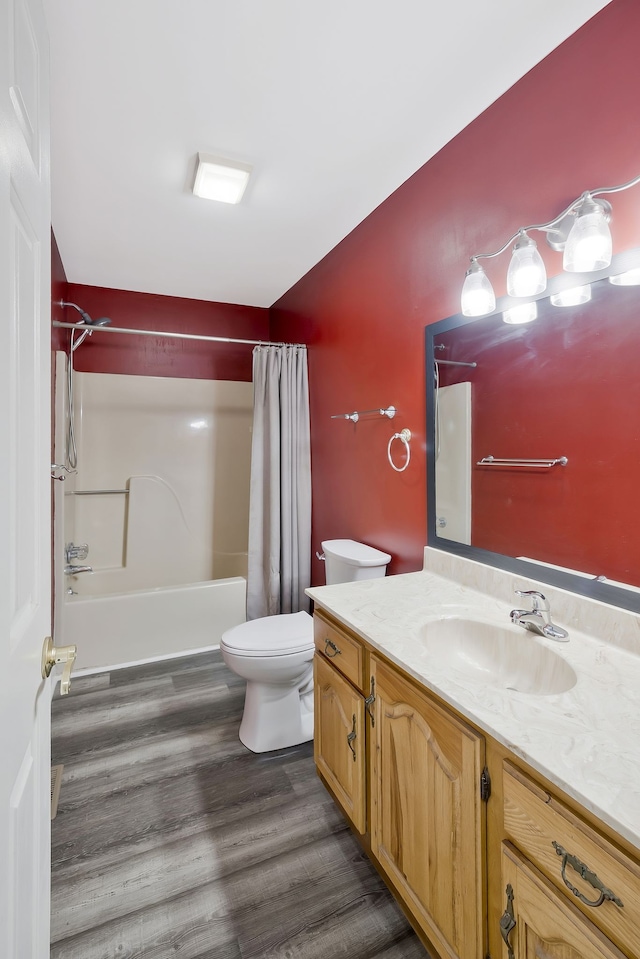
[501,843,625,959]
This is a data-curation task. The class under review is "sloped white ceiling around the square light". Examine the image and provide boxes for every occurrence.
[44,0,608,306]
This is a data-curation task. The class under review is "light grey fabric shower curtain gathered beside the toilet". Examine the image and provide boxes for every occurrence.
[247,346,311,619]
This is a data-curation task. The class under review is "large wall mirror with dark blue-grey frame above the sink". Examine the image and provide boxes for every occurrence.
[426,250,640,612]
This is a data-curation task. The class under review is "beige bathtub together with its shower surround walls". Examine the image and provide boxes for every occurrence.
[54,364,253,669]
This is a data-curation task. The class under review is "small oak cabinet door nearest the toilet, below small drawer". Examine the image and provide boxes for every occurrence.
[313,653,366,833]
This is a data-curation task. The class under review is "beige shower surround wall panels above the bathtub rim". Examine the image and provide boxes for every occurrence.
[65,370,252,595]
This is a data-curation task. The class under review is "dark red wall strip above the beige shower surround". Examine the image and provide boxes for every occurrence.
[60,283,269,381]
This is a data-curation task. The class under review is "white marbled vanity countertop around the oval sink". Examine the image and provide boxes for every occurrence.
[307,571,640,850]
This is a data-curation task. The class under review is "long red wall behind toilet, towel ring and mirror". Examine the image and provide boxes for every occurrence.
[271,0,640,583]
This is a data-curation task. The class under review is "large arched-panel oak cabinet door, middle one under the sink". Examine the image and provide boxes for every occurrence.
[370,656,486,959]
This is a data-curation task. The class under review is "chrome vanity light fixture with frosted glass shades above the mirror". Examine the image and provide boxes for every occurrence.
[461,176,640,322]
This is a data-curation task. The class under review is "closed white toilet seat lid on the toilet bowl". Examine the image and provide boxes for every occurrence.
[221,612,313,656]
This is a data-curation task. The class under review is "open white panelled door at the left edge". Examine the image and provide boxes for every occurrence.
[0,0,51,959]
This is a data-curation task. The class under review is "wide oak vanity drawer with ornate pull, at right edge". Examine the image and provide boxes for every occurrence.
[503,762,640,956]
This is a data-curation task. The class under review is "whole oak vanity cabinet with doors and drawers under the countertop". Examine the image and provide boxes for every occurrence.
[314,613,640,959]
